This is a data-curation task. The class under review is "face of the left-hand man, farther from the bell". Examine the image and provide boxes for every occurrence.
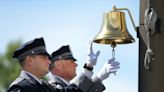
[29,55,50,77]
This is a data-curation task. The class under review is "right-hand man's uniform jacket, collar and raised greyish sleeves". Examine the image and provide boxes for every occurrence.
[49,74,105,92]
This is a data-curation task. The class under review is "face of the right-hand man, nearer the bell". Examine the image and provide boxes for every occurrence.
[56,59,77,80]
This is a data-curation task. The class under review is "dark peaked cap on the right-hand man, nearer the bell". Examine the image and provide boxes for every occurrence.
[51,45,76,61]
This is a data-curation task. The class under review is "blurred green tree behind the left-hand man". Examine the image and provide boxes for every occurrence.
[0,40,21,92]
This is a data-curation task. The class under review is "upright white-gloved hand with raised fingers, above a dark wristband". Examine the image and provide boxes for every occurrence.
[86,41,100,67]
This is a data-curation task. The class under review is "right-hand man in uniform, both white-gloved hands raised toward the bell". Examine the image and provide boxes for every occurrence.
[49,43,119,92]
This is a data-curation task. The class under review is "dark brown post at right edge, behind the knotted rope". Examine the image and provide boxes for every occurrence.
[139,0,164,92]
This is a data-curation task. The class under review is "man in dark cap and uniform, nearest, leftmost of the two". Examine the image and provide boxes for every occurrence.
[7,37,82,92]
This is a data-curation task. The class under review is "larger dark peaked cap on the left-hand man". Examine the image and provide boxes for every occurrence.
[13,37,50,61]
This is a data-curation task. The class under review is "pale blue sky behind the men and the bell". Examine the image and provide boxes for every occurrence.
[0,0,140,92]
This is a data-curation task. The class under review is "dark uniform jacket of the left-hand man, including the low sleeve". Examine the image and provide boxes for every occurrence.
[7,72,82,92]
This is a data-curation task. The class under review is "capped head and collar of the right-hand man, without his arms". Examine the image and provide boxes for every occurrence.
[49,45,77,89]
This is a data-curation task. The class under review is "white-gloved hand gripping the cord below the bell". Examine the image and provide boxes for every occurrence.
[97,58,120,80]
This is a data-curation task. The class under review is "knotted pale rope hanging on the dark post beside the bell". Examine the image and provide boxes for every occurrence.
[144,5,157,70]
